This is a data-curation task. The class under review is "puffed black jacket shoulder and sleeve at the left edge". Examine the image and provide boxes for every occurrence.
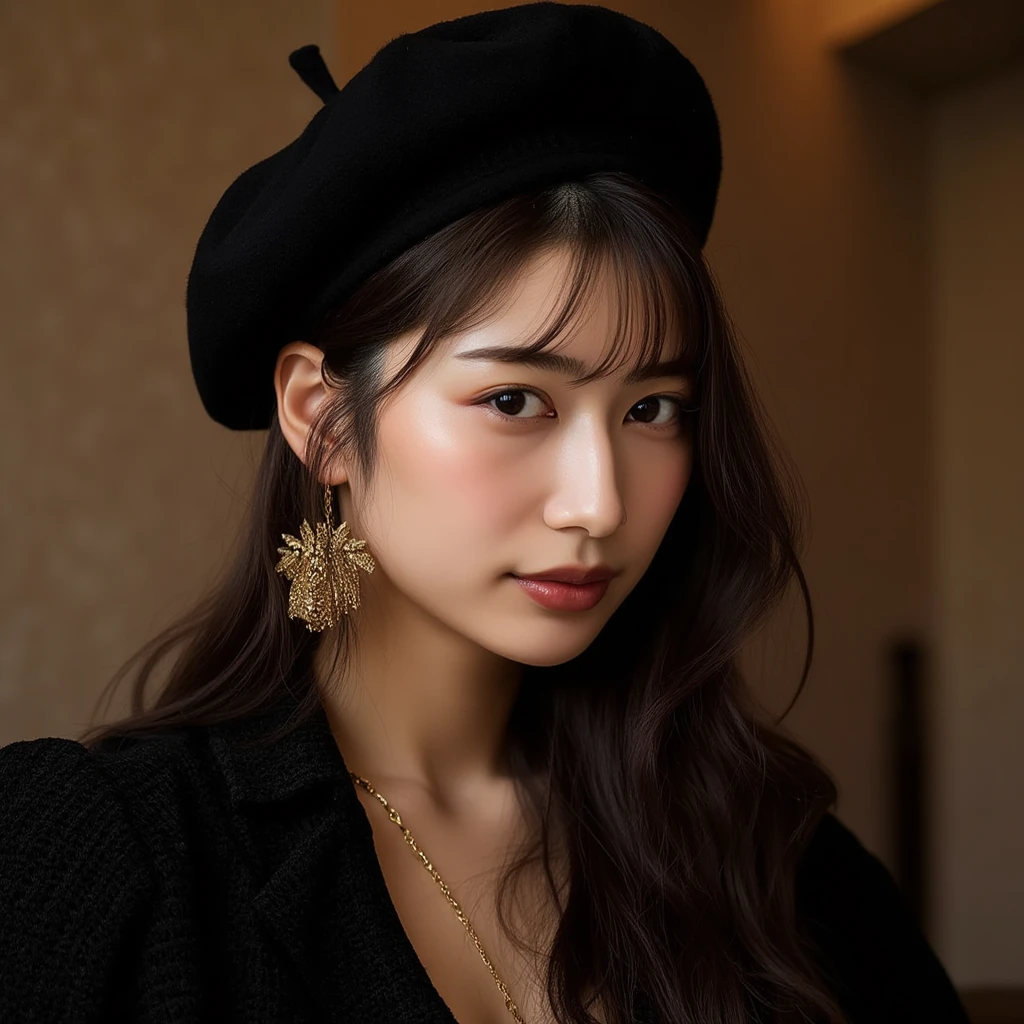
[0,737,160,1021]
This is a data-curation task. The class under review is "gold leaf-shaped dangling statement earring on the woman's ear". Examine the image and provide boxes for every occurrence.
[274,483,376,633]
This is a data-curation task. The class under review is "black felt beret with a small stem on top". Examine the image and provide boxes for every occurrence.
[185,2,722,430]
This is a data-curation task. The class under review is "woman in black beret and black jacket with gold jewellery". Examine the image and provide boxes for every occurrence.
[0,3,966,1024]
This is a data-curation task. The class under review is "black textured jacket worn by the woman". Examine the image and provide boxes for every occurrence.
[0,696,967,1024]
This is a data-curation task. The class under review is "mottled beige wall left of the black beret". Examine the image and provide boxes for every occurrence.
[0,0,337,742]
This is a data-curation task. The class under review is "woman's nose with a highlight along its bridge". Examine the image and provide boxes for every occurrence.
[544,417,626,537]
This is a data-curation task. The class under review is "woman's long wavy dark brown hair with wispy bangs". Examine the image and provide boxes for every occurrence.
[82,173,844,1024]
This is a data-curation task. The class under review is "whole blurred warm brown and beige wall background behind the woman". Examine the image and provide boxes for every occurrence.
[0,0,1024,1007]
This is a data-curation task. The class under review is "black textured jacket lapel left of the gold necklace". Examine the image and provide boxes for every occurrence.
[207,698,456,1024]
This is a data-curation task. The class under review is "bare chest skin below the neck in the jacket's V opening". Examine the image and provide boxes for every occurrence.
[356,782,604,1024]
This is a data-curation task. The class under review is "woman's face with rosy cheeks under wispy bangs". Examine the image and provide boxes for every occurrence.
[341,243,693,666]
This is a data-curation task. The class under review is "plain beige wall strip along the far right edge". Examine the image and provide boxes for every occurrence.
[931,65,1024,984]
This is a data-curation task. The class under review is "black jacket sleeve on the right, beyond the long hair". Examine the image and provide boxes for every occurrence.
[797,813,968,1024]
